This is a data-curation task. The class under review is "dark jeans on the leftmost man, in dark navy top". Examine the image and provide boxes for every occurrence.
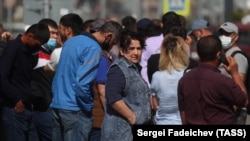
[2,107,38,141]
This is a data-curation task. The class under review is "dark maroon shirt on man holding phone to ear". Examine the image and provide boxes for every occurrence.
[178,64,247,124]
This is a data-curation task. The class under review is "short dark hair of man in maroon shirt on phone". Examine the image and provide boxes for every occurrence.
[197,35,222,62]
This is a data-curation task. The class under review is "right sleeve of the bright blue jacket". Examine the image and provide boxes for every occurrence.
[75,45,101,112]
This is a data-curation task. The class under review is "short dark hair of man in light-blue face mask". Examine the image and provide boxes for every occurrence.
[25,23,50,44]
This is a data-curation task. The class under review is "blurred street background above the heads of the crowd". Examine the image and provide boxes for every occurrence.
[0,0,250,33]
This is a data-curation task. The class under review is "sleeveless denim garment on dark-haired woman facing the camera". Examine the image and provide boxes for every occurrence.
[102,57,151,141]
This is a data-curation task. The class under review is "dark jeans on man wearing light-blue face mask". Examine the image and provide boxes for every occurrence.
[33,109,53,141]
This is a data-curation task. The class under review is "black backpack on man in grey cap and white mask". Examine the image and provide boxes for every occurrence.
[231,50,250,115]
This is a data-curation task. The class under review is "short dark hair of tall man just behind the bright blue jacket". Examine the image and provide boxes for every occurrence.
[59,13,83,35]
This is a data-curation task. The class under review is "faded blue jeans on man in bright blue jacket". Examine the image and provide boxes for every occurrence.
[52,109,92,141]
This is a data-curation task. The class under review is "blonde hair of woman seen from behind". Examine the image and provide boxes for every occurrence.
[159,34,189,74]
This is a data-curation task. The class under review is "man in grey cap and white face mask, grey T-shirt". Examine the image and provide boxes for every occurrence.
[218,22,249,124]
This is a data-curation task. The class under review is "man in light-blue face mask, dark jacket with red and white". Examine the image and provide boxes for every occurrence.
[31,18,58,141]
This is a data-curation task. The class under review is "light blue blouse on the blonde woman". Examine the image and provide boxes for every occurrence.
[151,70,184,125]
